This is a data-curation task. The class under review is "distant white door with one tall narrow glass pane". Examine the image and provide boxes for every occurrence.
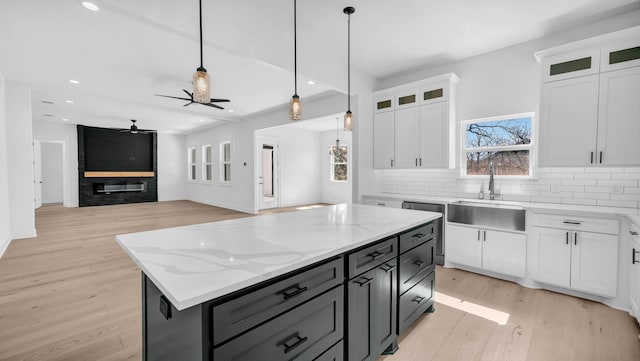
[256,137,280,209]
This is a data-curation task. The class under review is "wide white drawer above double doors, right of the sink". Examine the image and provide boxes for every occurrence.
[531,213,620,234]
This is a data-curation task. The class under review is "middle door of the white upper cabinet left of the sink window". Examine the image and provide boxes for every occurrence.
[394,107,419,168]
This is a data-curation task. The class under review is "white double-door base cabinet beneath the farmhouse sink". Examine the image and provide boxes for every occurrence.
[445,223,527,277]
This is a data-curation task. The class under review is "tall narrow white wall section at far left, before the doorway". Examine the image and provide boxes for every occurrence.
[5,82,36,239]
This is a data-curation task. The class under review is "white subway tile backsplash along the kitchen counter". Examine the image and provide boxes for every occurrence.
[382,167,640,208]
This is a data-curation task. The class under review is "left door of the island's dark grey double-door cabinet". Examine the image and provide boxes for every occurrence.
[347,268,378,361]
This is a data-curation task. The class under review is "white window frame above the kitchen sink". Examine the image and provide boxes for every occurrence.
[459,112,537,179]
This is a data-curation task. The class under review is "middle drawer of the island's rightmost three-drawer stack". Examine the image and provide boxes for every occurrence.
[400,238,435,294]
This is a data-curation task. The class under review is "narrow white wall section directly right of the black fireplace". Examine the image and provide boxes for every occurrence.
[158,134,187,201]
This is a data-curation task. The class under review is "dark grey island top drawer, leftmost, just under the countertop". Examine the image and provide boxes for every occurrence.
[213,258,344,345]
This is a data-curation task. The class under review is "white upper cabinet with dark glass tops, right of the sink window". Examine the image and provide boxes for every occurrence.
[536,27,640,167]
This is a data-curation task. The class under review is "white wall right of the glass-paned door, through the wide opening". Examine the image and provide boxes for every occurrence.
[256,126,321,207]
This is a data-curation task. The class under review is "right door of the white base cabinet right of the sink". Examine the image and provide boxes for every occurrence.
[570,232,618,297]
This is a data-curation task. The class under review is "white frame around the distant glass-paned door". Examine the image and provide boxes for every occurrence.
[254,135,282,213]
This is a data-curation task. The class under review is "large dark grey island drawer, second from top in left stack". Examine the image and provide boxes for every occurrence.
[213,286,344,361]
